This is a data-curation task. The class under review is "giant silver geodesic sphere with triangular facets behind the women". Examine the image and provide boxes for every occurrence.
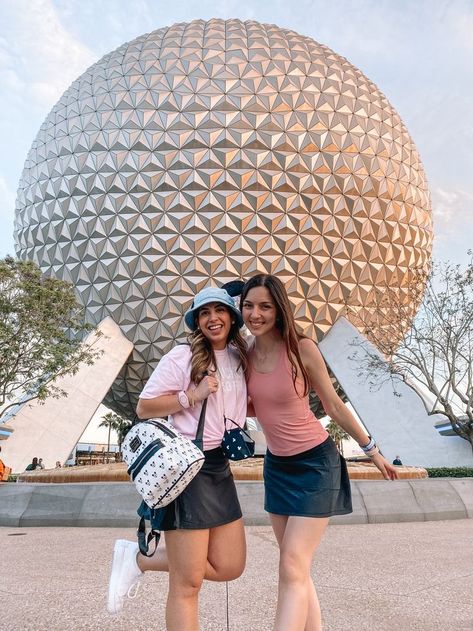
[15,20,432,416]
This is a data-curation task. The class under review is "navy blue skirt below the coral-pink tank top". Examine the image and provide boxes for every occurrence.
[264,437,353,517]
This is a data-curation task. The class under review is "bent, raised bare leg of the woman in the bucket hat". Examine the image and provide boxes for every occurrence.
[136,519,246,581]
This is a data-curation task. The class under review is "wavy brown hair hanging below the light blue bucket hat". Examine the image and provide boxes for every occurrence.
[187,305,247,384]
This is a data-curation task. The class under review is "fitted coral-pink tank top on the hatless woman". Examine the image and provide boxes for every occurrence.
[247,345,328,456]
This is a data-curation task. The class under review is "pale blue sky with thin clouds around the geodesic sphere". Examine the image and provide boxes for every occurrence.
[0,0,473,262]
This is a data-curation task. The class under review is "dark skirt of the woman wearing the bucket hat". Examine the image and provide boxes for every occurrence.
[138,447,242,531]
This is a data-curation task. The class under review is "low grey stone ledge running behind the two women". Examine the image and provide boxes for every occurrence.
[0,478,473,527]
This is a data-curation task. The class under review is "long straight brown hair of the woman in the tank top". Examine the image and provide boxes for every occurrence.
[240,274,310,396]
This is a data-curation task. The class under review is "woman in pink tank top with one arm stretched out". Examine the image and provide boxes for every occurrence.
[240,274,397,631]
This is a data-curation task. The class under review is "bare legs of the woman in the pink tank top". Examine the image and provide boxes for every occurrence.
[270,515,328,631]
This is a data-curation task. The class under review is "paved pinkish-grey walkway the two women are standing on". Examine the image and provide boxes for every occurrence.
[0,520,473,631]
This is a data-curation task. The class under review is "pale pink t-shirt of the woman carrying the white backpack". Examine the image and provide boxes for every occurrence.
[140,344,247,449]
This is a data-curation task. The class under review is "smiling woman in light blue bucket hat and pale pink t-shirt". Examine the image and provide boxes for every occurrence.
[108,288,247,631]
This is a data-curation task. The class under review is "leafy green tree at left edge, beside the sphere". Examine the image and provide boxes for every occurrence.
[0,256,101,416]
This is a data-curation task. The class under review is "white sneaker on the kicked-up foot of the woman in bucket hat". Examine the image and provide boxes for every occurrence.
[107,539,143,613]
